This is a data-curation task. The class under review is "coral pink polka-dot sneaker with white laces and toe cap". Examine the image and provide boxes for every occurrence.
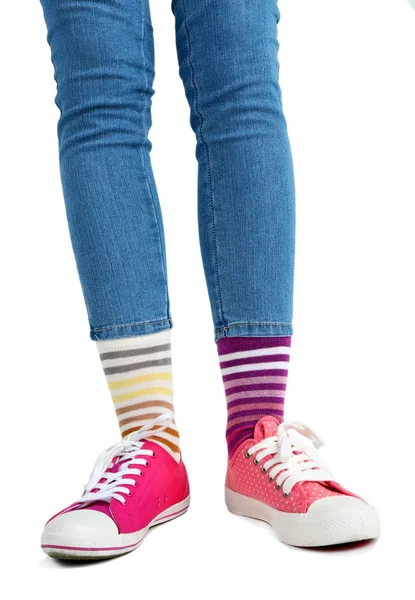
[225,416,380,546]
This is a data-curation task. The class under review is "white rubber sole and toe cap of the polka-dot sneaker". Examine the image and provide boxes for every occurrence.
[225,487,380,547]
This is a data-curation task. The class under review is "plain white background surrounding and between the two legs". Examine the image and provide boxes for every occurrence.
[0,0,415,600]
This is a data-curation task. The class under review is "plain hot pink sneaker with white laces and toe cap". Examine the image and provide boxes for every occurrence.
[41,416,190,559]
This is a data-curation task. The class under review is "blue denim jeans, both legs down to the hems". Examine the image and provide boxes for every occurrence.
[41,0,295,340]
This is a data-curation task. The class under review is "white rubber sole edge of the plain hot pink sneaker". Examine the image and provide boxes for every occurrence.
[41,496,190,560]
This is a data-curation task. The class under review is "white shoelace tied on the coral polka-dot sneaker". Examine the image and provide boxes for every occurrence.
[245,421,336,496]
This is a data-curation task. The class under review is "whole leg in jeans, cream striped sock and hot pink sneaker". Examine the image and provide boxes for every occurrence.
[42,0,189,559]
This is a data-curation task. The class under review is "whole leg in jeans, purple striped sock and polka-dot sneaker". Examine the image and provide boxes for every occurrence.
[173,0,379,546]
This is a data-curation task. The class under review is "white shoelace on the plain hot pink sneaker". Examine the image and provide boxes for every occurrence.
[77,413,172,507]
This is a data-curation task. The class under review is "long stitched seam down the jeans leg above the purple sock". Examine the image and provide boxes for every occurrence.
[182,0,225,323]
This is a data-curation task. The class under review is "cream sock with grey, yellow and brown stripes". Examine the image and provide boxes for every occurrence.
[97,329,180,462]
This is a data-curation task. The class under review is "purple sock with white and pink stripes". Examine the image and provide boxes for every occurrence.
[217,336,291,456]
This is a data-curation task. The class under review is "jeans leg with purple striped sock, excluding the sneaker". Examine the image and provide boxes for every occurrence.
[173,0,295,455]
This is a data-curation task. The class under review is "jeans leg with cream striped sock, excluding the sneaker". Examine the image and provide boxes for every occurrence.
[42,0,180,459]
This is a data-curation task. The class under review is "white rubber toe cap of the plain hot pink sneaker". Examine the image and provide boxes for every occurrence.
[42,509,118,546]
